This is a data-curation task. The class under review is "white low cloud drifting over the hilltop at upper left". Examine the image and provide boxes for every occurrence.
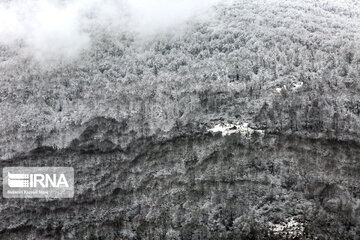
[0,0,217,60]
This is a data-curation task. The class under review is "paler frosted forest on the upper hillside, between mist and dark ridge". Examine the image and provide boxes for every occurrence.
[0,1,360,158]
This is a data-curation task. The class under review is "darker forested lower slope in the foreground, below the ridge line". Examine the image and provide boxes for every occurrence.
[0,118,360,239]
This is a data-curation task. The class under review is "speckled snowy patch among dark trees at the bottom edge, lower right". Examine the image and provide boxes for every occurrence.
[268,217,305,238]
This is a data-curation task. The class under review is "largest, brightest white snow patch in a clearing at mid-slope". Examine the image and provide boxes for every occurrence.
[208,123,265,136]
